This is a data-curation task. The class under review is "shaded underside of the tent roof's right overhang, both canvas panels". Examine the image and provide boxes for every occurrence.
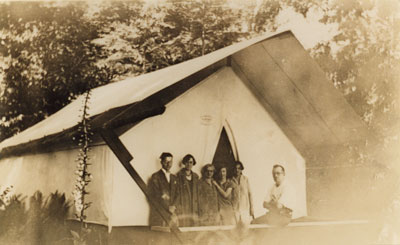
[231,32,374,159]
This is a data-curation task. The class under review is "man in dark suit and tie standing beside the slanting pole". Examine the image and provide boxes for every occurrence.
[148,152,178,226]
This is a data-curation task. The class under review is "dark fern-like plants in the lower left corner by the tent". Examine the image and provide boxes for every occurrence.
[0,191,70,244]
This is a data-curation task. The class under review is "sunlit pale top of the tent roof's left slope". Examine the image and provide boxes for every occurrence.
[0,30,284,155]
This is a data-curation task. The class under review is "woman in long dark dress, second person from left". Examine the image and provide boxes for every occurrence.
[177,154,199,227]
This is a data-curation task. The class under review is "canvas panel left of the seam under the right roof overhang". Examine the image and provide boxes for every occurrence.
[233,44,337,146]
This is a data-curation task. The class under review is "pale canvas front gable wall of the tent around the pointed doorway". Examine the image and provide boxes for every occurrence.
[112,67,306,226]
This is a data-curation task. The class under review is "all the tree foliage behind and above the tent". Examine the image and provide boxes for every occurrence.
[0,0,400,153]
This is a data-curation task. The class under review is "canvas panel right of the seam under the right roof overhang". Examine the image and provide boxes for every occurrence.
[262,36,368,142]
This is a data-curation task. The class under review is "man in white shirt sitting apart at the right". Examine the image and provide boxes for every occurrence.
[253,164,296,226]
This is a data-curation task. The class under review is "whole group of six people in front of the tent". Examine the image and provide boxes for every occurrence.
[148,152,292,227]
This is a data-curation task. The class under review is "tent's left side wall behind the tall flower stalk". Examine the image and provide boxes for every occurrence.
[0,145,112,225]
